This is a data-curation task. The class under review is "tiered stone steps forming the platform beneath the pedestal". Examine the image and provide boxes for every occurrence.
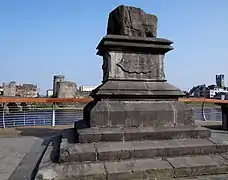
[36,127,228,180]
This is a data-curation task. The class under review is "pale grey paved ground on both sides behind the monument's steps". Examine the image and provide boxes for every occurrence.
[0,121,224,180]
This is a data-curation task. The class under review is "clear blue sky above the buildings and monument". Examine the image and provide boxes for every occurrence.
[0,0,228,92]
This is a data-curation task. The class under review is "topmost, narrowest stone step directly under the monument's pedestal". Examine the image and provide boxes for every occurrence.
[77,126,211,143]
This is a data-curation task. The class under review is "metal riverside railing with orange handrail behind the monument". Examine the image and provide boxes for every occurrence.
[0,98,222,128]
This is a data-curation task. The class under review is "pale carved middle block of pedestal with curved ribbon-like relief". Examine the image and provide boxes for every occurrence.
[103,51,165,81]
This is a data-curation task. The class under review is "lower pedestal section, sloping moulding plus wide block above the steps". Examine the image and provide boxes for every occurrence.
[84,80,194,128]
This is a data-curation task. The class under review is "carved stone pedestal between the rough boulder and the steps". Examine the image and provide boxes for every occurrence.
[84,35,194,127]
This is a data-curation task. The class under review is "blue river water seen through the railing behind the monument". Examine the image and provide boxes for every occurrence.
[0,107,222,128]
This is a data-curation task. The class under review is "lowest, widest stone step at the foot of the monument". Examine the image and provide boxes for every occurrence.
[36,155,228,180]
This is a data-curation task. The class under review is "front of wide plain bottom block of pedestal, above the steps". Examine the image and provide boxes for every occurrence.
[89,100,194,128]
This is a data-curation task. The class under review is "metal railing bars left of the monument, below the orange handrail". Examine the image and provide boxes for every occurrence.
[0,108,83,128]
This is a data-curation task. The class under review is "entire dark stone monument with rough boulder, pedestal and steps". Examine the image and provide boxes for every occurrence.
[36,6,228,180]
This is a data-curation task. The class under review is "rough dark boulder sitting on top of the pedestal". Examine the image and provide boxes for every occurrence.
[107,5,158,37]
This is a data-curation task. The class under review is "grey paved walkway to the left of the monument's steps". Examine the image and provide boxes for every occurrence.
[0,126,70,180]
